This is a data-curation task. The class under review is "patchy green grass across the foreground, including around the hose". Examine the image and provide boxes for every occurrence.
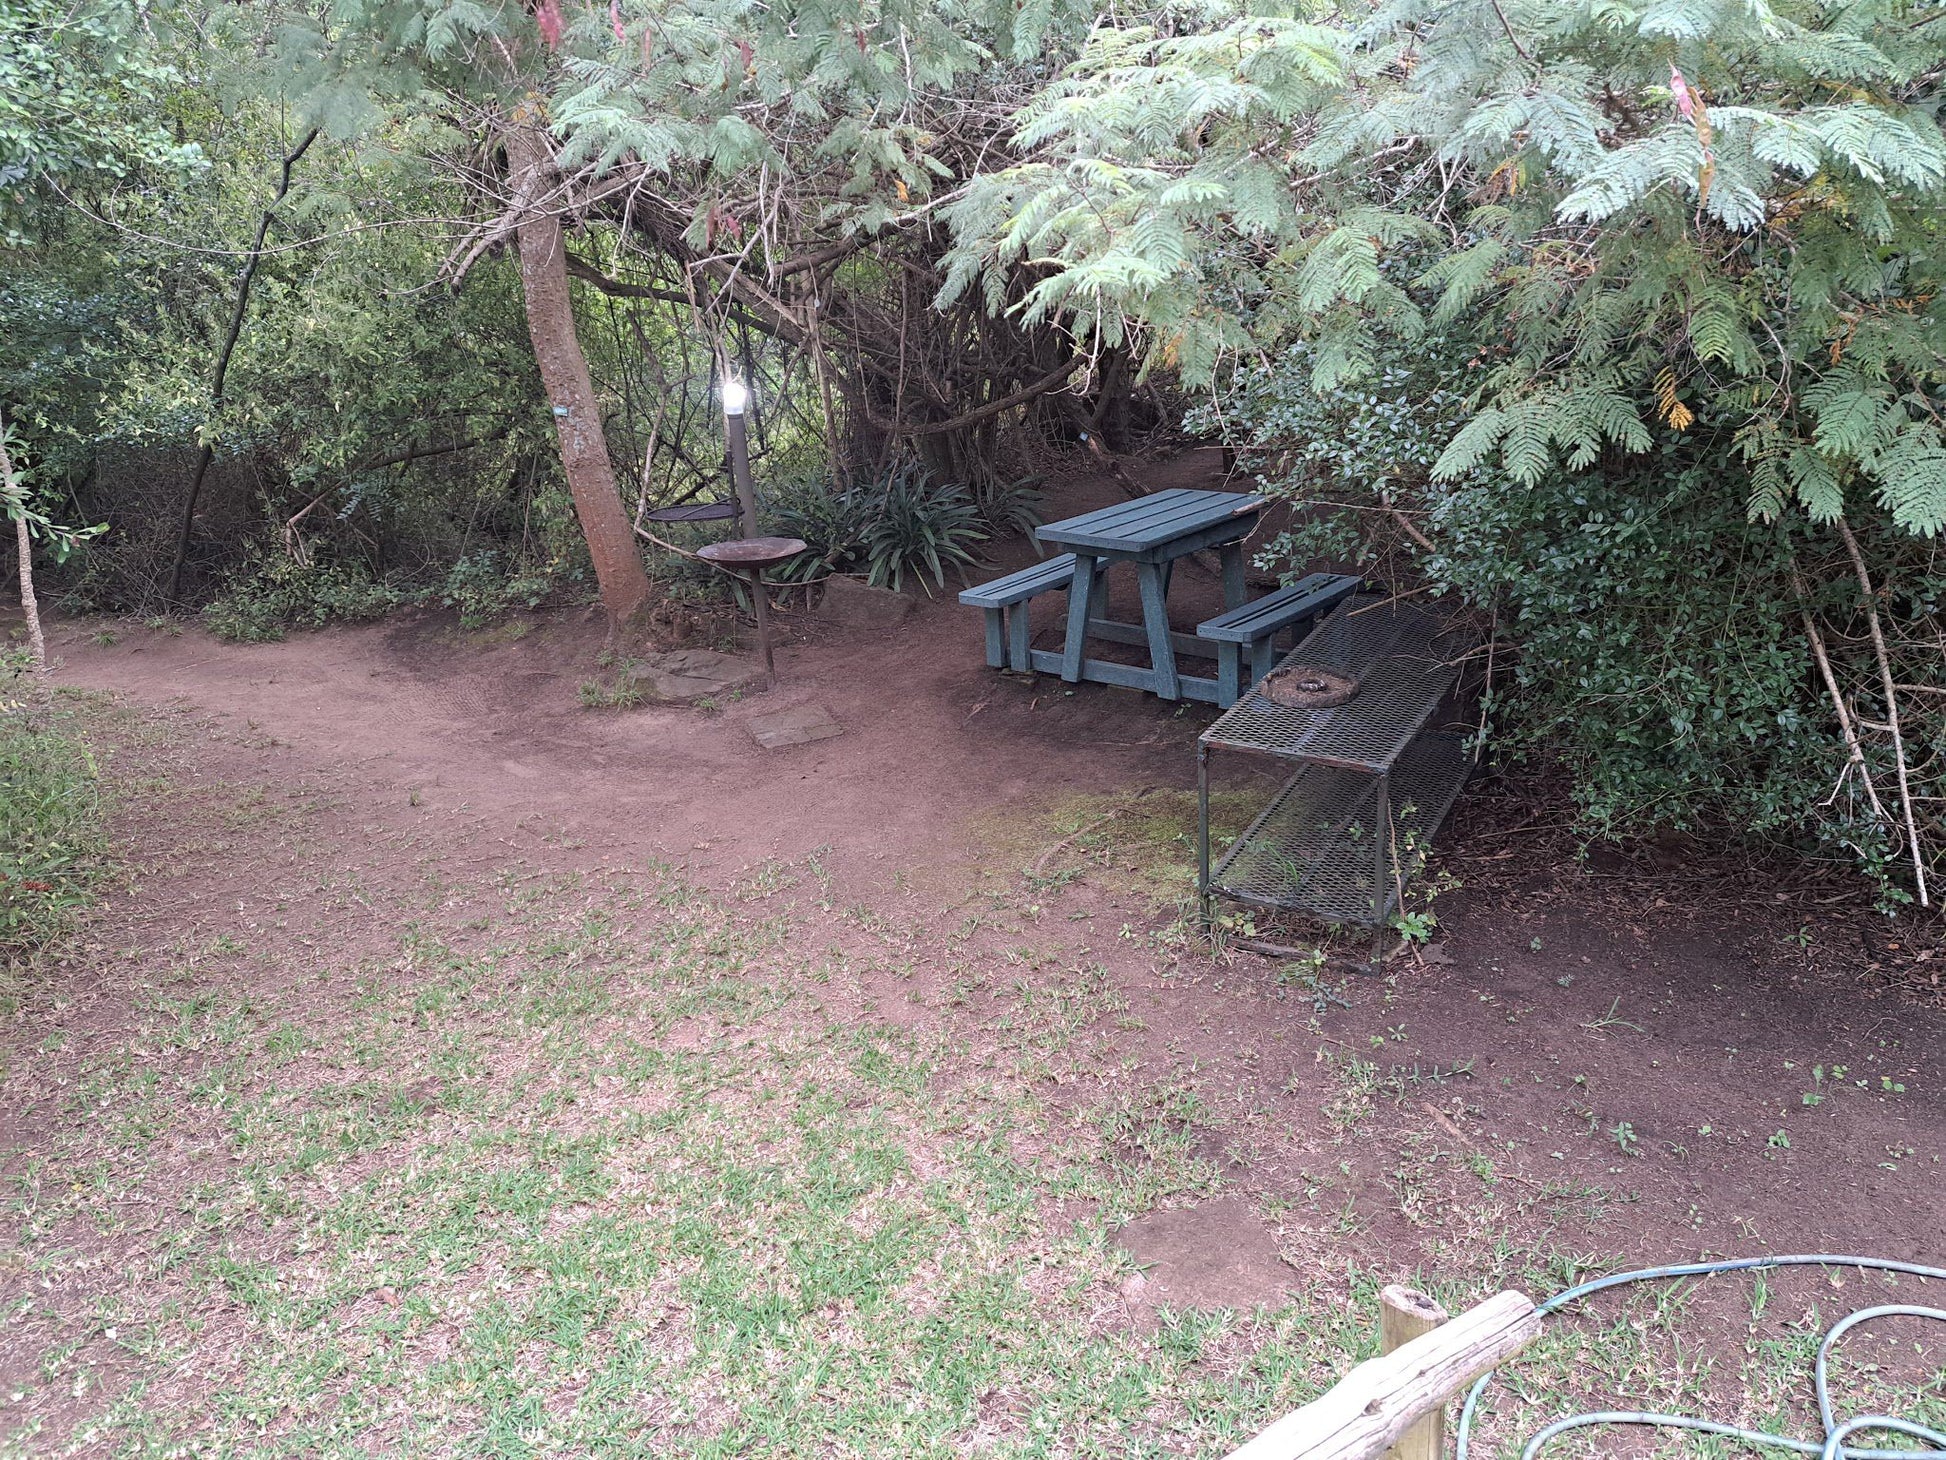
[0,728,1946,1460]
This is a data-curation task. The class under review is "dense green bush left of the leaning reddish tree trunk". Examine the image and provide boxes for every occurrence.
[0,162,582,623]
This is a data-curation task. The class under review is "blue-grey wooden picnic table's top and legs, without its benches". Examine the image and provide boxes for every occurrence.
[1033,487,1265,705]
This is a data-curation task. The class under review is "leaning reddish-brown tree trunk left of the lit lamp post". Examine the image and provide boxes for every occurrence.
[506,118,648,627]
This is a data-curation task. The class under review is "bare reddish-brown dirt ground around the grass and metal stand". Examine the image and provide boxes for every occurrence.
[0,457,1946,1456]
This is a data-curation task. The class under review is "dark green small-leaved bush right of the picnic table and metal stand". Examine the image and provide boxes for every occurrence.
[1199,339,1946,901]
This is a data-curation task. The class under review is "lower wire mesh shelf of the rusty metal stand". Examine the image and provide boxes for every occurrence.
[1210,734,1473,927]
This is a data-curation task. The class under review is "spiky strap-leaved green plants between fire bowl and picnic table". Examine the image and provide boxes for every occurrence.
[767,461,991,592]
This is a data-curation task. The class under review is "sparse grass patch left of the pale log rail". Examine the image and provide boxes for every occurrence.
[0,880,1393,1460]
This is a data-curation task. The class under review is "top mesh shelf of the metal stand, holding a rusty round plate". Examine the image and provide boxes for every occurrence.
[1203,598,1465,775]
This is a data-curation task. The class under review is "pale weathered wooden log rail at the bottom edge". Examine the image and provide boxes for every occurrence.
[1228,1293,1541,1460]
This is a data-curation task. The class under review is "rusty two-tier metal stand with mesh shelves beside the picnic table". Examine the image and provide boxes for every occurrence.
[1197,596,1475,969]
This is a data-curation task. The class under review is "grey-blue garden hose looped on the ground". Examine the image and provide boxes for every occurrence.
[1456,1252,1946,1460]
